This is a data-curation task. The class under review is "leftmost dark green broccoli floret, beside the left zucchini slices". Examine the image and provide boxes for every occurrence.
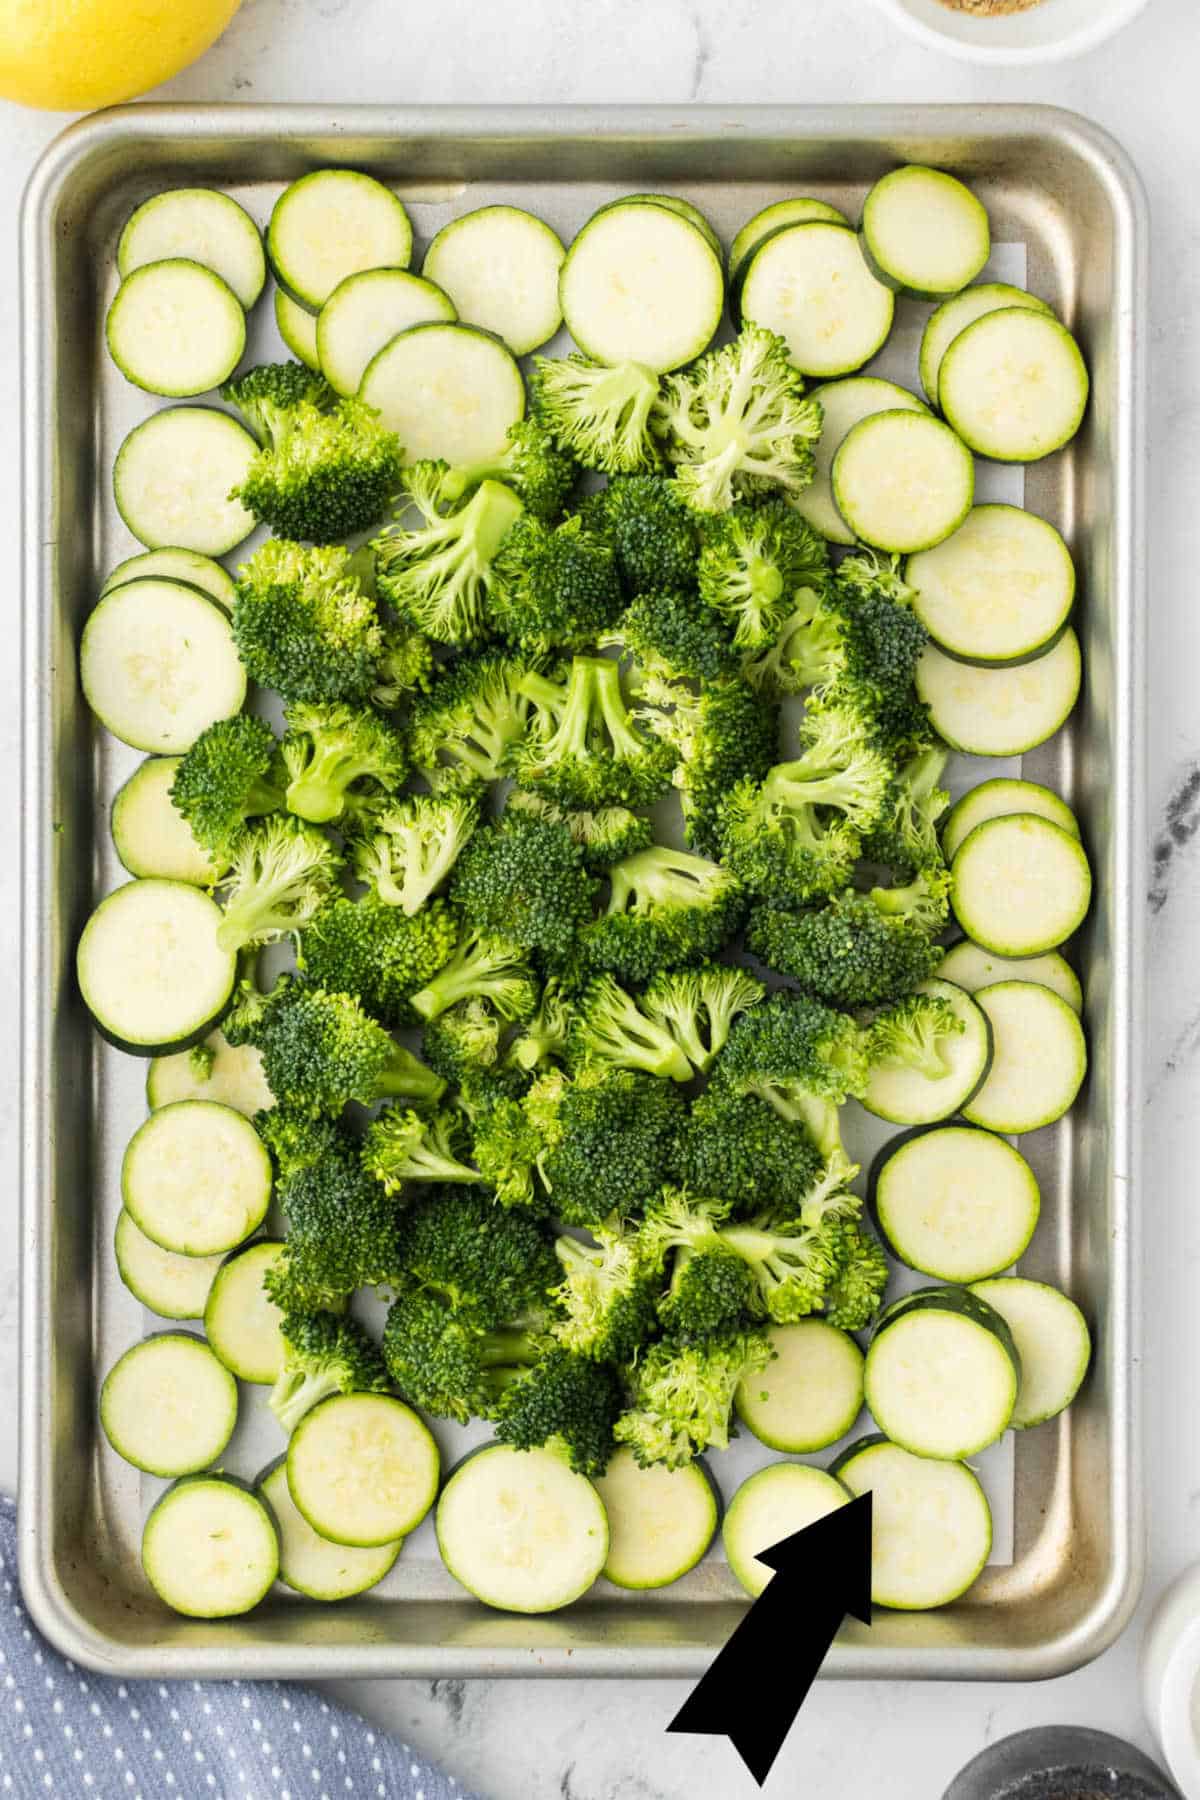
[171,713,282,857]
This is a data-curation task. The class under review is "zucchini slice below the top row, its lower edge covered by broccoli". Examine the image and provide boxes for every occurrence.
[358,324,525,468]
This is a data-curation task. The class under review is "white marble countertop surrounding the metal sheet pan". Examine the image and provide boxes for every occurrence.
[0,0,1200,1800]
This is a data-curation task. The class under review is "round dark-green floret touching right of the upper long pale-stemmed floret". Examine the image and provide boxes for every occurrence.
[489,515,621,655]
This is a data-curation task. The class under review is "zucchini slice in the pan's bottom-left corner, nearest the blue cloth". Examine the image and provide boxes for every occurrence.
[142,1474,279,1618]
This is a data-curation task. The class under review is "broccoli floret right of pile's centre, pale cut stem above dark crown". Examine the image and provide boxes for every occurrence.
[583,844,743,981]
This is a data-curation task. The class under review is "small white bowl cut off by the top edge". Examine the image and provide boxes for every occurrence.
[874,0,1148,65]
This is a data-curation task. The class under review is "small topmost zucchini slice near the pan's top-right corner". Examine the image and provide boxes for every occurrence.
[862,162,991,301]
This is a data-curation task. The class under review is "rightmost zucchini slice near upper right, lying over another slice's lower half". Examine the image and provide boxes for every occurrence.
[937,306,1088,463]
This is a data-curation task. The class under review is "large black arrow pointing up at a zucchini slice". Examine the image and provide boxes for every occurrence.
[667,1492,871,1787]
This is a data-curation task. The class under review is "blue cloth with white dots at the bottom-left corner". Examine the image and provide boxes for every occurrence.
[0,1496,471,1800]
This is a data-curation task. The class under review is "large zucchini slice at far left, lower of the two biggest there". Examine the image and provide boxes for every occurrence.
[76,880,237,1057]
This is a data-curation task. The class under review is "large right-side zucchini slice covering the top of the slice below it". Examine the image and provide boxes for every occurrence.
[905,504,1076,666]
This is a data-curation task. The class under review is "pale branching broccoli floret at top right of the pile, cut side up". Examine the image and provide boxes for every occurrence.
[653,326,820,513]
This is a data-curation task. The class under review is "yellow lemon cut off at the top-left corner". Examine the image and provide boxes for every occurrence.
[0,0,241,112]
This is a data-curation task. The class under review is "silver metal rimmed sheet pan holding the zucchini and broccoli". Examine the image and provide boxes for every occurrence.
[20,106,1146,1679]
